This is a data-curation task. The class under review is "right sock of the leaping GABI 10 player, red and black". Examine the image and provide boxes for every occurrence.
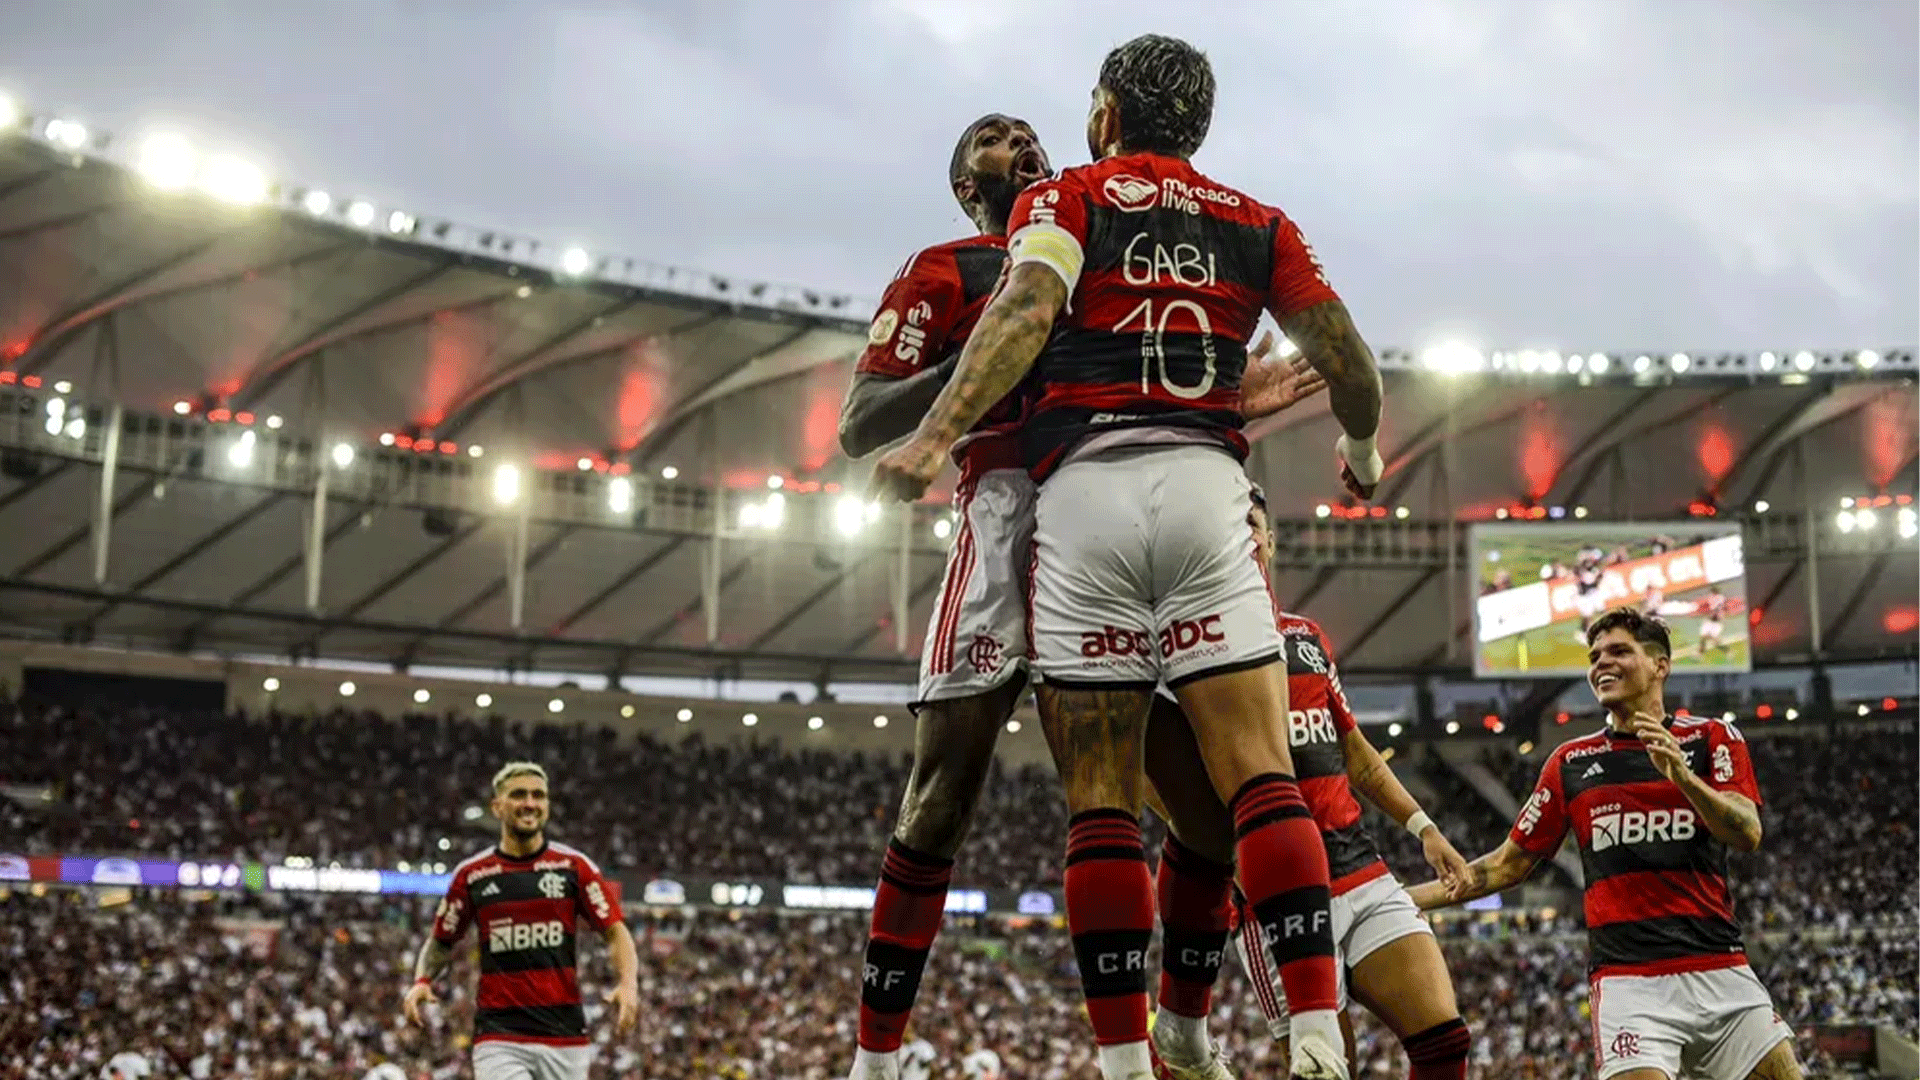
[1231,773,1338,1013]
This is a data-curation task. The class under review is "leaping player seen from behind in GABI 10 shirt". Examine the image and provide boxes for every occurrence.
[876,35,1384,1080]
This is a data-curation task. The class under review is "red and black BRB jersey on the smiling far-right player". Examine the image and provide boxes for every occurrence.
[1509,717,1761,978]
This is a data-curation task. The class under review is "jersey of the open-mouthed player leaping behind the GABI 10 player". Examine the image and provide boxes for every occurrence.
[854,236,1023,471]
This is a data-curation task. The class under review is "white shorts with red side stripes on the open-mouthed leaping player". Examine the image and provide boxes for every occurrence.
[914,469,1033,709]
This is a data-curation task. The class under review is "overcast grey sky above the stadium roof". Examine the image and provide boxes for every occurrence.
[0,0,1920,352]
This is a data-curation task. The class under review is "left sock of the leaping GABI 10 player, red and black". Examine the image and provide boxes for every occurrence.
[1066,809,1154,1045]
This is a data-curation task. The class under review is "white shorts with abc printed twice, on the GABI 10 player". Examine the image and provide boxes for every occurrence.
[1033,446,1281,690]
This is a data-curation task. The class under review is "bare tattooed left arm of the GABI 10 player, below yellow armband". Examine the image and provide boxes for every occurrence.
[918,263,1068,445]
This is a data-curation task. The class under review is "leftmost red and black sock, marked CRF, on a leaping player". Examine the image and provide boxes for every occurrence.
[860,840,954,1053]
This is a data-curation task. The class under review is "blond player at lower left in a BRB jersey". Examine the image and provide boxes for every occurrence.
[403,761,639,1080]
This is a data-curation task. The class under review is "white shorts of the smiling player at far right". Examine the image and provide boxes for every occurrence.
[1590,965,1793,1080]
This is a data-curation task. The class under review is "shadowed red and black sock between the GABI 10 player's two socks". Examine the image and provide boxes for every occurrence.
[1154,836,1233,1019]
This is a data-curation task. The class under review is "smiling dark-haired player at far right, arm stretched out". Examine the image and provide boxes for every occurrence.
[1411,607,1803,1080]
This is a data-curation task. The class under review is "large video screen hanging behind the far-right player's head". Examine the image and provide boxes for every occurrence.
[1471,521,1753,678]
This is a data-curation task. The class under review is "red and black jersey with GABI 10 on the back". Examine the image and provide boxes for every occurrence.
[1008,154,1338,479]
